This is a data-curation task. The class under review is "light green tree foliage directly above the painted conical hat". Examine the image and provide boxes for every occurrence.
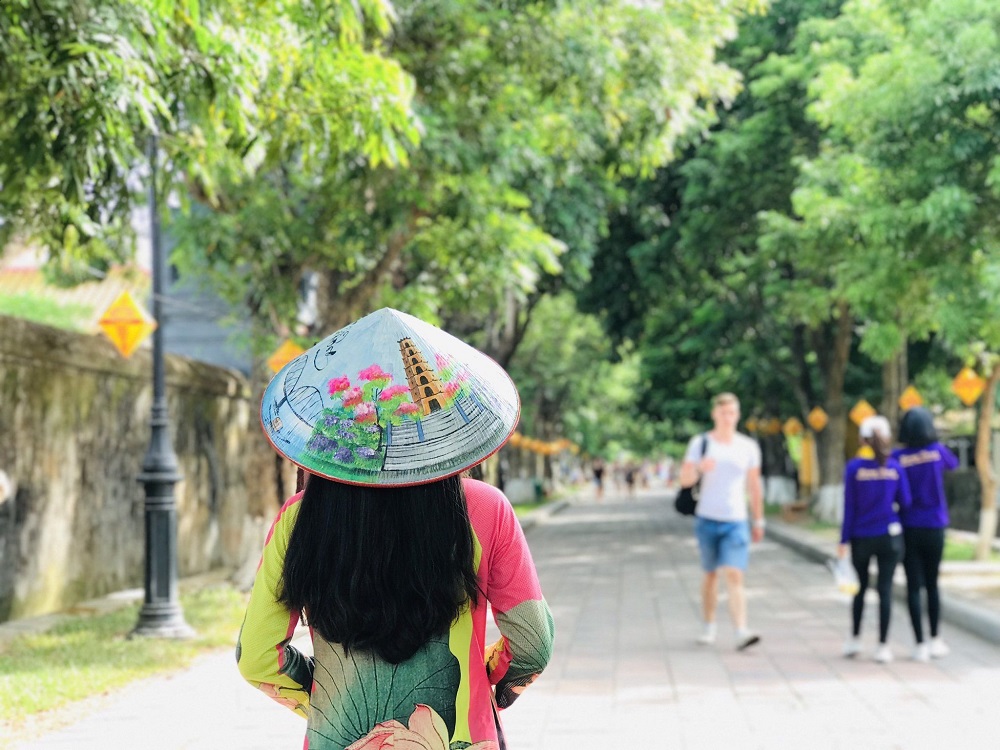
[168,0,753,361]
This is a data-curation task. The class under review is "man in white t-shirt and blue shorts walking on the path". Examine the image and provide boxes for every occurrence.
[680,393,764,651]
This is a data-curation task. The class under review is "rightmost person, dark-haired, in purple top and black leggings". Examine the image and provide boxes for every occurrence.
[892,407,958,661]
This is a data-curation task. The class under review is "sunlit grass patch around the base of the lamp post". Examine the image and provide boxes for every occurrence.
[0,586,247,724]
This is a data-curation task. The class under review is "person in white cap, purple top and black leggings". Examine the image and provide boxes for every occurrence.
[837,416,910,663]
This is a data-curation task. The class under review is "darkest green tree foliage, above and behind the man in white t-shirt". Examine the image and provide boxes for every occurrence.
[583,0,850,428]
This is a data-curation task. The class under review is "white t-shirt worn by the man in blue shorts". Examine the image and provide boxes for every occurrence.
[684,432,760,521]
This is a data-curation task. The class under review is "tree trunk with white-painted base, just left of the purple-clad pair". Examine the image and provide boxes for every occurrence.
[816,303,854,521]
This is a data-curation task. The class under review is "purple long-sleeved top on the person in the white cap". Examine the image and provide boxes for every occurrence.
[840,458,910,544]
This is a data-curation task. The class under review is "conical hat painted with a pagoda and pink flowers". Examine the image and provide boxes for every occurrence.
[260,308,520,487]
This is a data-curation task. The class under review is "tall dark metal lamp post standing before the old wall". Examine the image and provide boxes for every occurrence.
[132,135,194,638]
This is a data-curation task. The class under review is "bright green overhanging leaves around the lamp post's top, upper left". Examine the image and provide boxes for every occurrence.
[0,0,413,279]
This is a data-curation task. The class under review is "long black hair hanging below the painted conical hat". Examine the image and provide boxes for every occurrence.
[279,475,478,664]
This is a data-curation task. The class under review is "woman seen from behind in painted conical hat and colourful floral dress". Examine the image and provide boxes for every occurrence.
[237,309,553,750]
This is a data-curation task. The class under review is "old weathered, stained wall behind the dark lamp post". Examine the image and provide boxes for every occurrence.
[0,316,294,621]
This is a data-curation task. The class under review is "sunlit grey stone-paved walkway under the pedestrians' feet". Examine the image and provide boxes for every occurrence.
[13,492,1000,750]
